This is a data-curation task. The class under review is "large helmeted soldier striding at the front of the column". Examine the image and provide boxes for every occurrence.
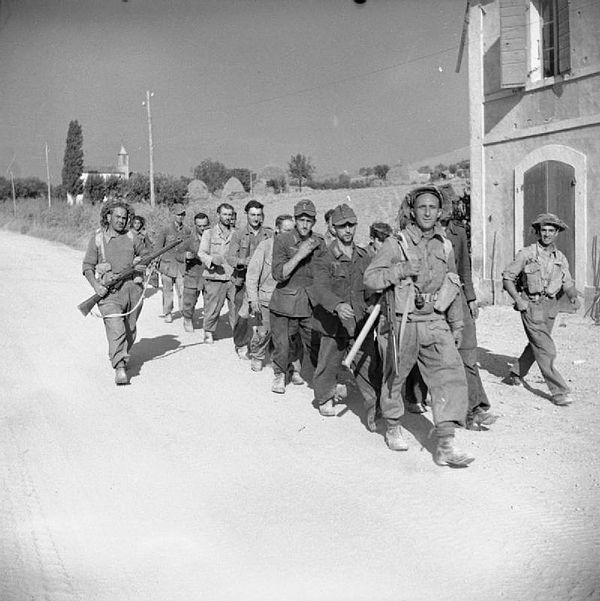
[364,186,474,467]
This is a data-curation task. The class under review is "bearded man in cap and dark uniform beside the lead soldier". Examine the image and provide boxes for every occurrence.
[311,204,382,420]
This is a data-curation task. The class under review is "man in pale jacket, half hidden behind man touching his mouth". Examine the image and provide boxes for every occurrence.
[246,215,300,372]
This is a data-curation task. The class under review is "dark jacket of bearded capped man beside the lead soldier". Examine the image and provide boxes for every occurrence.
[311,240,371,338]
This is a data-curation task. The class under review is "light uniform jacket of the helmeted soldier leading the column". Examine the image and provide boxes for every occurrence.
[364,223,462,325]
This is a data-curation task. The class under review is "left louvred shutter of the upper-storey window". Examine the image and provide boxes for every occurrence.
[500,0,527,88]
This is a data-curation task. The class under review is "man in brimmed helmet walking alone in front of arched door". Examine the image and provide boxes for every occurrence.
[502,213,579,406]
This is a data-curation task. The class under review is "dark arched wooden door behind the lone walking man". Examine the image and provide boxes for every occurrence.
[523,161,575,269]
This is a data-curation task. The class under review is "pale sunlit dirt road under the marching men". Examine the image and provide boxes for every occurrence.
[0,232,600,601]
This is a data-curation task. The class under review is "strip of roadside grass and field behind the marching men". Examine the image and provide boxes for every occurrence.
[0,185,413,250]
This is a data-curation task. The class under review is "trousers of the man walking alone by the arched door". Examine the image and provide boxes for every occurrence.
[511,297,570,399]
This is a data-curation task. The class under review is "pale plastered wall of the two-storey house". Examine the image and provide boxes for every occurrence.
[469,0,600,302]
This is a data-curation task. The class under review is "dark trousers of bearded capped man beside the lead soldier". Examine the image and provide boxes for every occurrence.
[313,332,383,410]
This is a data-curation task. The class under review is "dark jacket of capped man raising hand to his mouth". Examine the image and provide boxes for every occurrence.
[269,229,326,317]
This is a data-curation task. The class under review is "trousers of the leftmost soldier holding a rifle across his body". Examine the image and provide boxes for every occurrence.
[98,280,142,367]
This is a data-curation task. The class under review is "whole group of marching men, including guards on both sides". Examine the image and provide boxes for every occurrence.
[83,185,578,467]
